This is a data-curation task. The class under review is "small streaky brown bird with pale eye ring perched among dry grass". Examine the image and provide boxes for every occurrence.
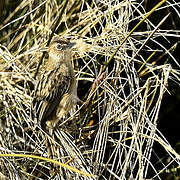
[32,37,79,129]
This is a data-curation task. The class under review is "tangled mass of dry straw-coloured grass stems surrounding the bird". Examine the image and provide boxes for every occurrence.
[0,0,180,179]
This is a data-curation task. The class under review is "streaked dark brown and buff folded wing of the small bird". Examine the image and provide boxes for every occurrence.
[32,71,72,124]
